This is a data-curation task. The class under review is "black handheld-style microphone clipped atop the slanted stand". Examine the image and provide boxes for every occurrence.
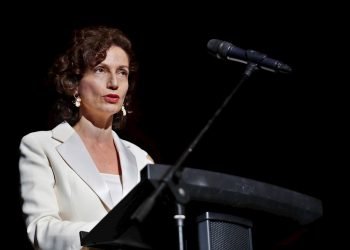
[207,39,292,73]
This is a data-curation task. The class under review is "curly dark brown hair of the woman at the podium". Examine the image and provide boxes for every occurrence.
[49,26,137,129]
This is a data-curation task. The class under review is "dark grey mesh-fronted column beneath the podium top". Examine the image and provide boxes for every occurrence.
[197,212,253,250]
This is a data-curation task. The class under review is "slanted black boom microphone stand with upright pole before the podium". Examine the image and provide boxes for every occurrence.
[131,62,258,250]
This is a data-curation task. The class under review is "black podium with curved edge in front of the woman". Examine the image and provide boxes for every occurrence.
[80,164,322,250]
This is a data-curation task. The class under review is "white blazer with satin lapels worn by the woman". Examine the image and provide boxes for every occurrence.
[19,122,152,250]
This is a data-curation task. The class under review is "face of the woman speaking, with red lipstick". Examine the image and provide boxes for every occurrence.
[78,46,129,121]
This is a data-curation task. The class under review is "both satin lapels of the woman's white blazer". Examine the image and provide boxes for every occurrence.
[52,122,140,209]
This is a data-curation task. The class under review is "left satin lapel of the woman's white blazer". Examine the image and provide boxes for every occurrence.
[53,123,113,209]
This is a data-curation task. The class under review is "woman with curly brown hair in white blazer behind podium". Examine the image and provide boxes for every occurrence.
[19,27,153,249]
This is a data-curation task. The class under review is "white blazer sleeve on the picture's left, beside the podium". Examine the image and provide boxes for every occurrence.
[19,133,98,250]
